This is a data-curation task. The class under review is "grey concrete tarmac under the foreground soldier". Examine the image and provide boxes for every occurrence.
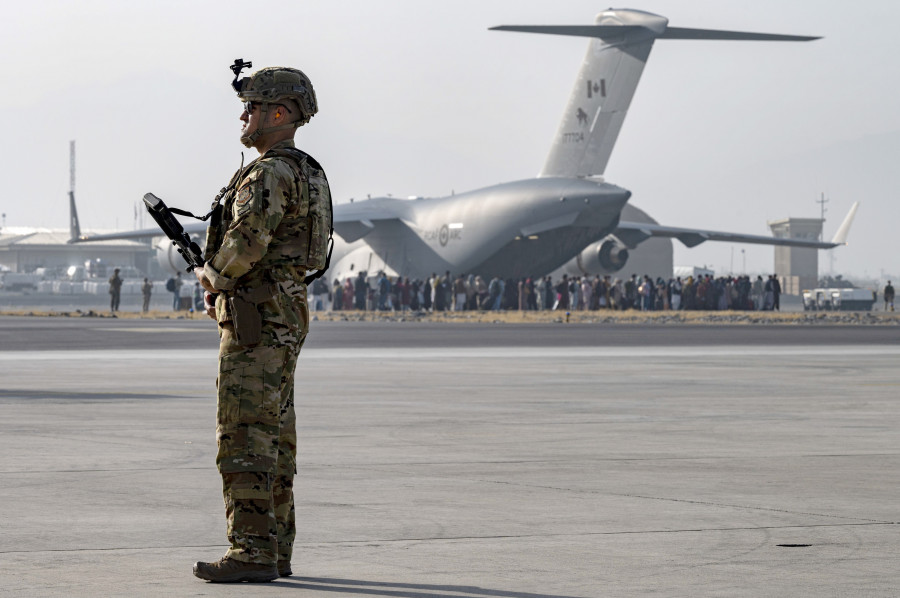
[0,317,900,598]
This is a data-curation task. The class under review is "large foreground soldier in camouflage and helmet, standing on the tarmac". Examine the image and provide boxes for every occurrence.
[194,62,332,582]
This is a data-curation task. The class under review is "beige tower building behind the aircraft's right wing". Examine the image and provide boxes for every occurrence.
[767,218,825,295]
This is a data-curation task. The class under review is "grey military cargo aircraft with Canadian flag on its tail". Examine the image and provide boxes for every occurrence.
[77,9,856,281]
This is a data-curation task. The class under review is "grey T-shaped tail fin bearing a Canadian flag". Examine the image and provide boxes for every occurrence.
[491,9,818,177]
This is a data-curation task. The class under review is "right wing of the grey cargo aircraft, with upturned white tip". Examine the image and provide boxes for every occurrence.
[613,202,859,249]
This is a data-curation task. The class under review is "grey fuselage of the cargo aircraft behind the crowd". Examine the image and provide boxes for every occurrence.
[329,177,631,280]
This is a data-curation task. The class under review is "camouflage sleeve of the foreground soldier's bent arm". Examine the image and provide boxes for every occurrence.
[204,160,294,291]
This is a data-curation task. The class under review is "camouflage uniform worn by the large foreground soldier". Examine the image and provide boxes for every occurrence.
[204,140,331,564]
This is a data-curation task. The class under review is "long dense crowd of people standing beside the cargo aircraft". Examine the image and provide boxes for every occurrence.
[311,272,781,311]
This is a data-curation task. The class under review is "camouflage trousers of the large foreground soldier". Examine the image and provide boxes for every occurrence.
[216,323,306,564]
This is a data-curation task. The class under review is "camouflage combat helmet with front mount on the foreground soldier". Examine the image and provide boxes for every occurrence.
[230,58,319,147]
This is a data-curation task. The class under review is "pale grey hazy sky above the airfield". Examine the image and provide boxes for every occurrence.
[0,0,900,276]
